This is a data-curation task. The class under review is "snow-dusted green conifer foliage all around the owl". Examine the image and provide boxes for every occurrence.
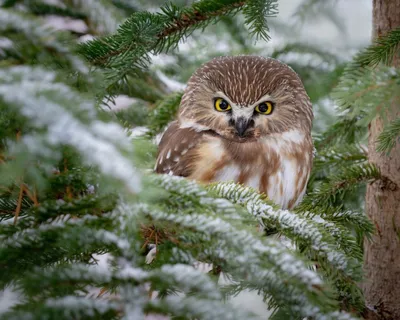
[0,0,400,319]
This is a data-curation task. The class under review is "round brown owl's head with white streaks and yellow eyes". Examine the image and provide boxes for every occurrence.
[179,56,313,142]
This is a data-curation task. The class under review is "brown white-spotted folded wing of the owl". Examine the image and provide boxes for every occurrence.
[155,121,203,177]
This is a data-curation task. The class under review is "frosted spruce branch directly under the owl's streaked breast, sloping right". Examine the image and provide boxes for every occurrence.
[211,183,361,278]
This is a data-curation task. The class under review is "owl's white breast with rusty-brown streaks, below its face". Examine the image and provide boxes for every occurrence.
[190,130,312,209]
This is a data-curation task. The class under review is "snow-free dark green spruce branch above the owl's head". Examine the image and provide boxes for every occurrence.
[78,0,276,92]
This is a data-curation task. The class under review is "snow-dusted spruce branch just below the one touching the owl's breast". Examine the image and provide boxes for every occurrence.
[135,205,338,316]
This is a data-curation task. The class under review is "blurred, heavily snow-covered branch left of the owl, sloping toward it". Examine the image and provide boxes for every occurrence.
[0,67,139,191]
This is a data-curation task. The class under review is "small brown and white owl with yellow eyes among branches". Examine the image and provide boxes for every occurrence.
[155,56,313,209]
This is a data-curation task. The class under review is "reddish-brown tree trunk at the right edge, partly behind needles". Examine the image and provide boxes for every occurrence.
[363,0,400,320]
